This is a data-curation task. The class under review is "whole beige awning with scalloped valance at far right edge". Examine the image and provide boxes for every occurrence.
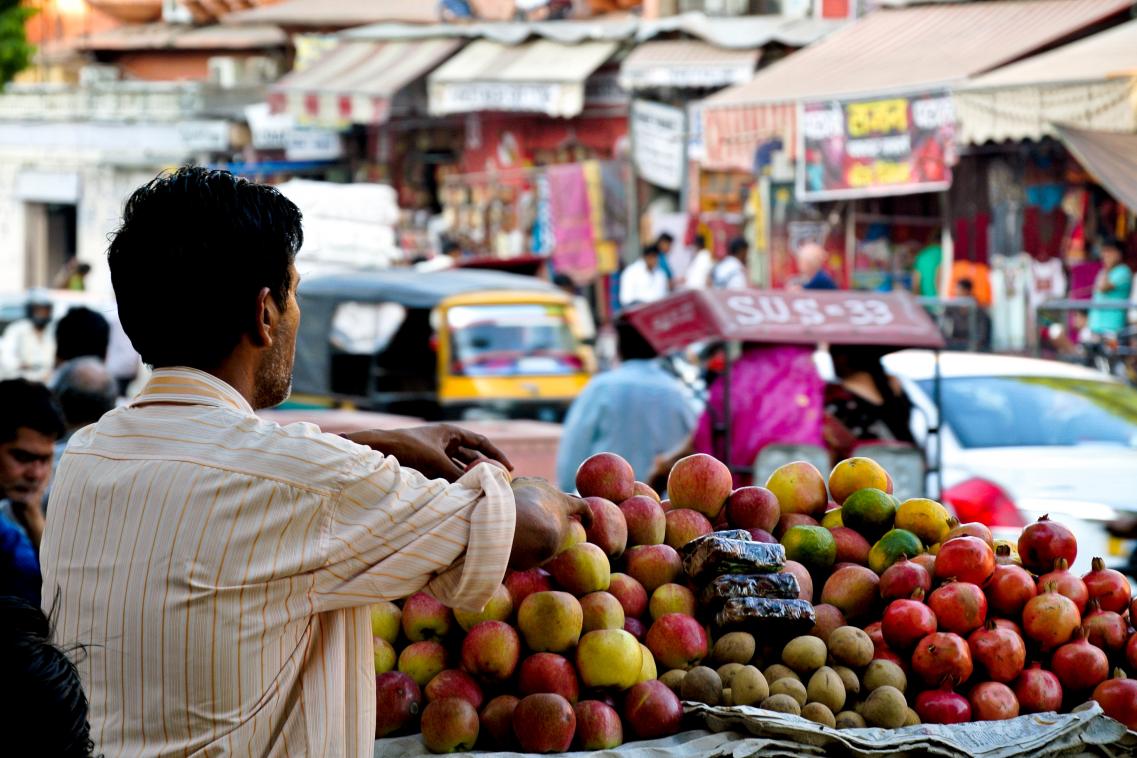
[955,20,1137,144]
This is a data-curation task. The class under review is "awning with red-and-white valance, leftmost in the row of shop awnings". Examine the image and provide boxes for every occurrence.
[269,39,463,126]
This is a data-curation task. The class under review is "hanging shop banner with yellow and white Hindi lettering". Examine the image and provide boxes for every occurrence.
[797,92,955,200]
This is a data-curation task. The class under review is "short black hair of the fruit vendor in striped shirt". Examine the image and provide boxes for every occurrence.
[107,167,304,369]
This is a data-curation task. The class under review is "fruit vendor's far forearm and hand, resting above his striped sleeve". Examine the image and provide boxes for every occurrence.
[342,424,513,482]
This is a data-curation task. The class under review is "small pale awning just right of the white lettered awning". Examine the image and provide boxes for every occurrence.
[620,40,762,90]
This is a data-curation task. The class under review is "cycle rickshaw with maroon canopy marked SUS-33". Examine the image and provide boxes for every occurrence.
[626,289,944,497]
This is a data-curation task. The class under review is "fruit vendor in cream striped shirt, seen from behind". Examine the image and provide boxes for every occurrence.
[41,168,590,758]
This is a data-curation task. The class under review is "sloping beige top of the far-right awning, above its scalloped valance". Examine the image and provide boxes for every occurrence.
[963,20,1137,90]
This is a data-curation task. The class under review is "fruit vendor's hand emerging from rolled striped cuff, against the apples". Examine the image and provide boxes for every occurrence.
[509,476,592,570]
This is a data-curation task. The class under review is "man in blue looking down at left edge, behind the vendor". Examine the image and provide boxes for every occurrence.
[0,380,64,602]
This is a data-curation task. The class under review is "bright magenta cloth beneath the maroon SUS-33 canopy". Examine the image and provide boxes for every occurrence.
[695,345,825,483]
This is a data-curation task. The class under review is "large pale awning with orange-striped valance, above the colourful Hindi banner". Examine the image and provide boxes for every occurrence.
[703,0,1132,169]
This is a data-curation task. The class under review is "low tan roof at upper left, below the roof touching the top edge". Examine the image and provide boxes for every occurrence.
[75,23,288,51]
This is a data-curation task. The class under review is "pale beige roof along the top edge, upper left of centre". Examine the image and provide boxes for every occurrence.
[223,0,439,28]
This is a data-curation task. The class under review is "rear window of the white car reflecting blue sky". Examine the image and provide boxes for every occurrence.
[920,376,1137,448]
